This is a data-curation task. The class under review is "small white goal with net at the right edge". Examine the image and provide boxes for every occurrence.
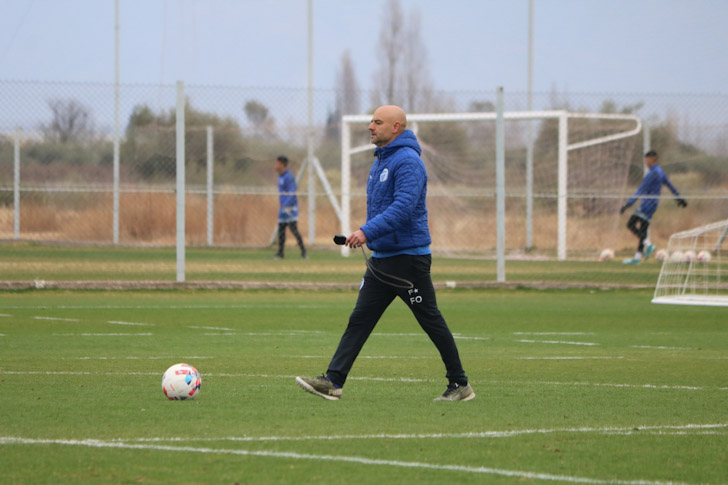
[652,219,728,306]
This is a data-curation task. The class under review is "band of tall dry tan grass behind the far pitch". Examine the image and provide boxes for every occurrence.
[0,187,726,257]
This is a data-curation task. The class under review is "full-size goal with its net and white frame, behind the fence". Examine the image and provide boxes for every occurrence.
[341,110,642,260]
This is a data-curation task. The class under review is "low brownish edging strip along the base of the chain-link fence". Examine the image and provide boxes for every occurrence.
[0,280,654,291]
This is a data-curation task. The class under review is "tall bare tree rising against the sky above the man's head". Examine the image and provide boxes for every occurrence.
[372,0,433,111]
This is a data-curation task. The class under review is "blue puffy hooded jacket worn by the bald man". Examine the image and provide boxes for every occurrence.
[361,130,432,257]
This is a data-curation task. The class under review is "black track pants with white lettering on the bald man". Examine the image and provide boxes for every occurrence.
[326,254,468,386]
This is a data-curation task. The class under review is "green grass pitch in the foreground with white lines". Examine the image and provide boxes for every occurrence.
[0,286,728,484]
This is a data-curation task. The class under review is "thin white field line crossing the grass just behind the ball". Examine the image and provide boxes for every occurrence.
[2,370,728,391]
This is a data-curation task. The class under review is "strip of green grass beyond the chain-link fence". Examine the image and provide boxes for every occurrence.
[0,243,660,288]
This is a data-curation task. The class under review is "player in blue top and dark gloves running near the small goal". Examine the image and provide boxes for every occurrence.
[619,150,688,264]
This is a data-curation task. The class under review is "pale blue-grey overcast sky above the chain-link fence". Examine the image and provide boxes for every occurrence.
[0,0,728,94]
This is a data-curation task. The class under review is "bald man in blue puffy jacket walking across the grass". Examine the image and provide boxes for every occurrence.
[296,106,475,401]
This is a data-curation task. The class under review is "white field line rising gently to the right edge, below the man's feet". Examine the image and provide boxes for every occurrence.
[114,423,728,443]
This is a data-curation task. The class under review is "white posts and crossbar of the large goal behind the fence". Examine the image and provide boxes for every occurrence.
[341,110,642,261]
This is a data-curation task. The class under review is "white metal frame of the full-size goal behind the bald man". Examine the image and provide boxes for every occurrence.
[341,110,642,261]
